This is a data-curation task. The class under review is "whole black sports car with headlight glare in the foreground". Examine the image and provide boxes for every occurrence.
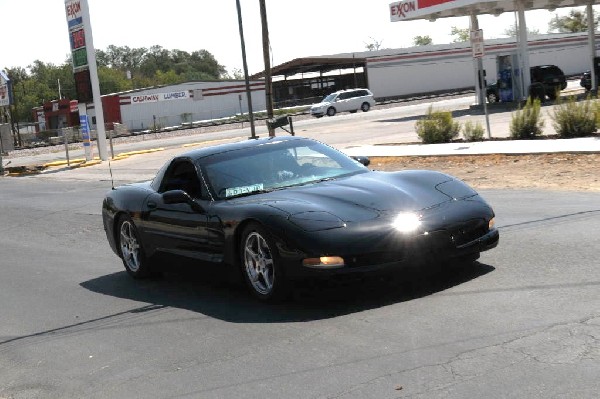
[102,137,499,300]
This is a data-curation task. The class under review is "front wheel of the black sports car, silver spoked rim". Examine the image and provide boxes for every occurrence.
[240,223,288,302]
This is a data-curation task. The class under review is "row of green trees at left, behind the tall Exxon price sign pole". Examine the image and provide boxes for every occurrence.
[6,45,228,122]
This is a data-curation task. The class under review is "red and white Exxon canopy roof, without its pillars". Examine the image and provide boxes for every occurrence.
[390,0,594,22]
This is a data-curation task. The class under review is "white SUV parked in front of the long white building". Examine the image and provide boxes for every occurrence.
[310,89,375,118]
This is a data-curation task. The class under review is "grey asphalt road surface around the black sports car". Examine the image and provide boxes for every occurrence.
[0,83,600,399]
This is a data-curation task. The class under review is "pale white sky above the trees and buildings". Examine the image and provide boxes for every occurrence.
[0,0,592,74]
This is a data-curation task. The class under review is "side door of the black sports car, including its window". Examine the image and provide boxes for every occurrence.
[142,159,208,259]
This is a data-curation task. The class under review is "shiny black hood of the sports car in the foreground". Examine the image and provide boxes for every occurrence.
[234,171,476,222]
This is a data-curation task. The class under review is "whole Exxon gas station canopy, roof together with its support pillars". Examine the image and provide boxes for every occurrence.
[389,0,597,102]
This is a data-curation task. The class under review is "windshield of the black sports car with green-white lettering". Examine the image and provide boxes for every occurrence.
[198,140,368,199]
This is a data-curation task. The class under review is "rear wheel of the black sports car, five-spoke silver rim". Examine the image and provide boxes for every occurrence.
[117,216,153,278]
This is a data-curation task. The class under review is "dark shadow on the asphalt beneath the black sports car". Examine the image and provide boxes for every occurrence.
[80,262,495,323]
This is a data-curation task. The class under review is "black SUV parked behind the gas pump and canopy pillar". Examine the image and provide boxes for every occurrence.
[486,65,567,103]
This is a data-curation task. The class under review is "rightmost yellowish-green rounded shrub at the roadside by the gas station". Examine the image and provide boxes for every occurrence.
[550,96,598,138]
